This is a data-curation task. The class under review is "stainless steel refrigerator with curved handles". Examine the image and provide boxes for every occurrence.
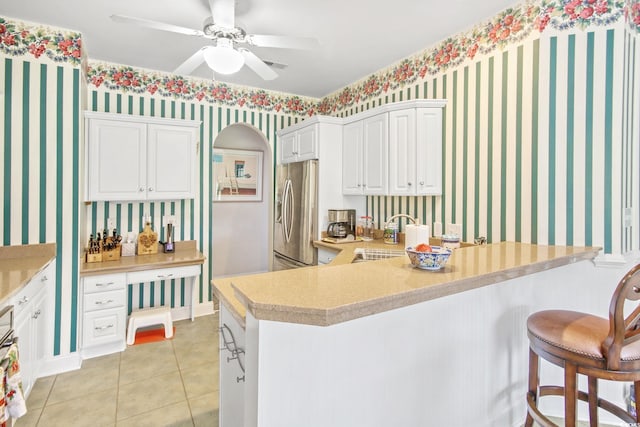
[273,160,318,270]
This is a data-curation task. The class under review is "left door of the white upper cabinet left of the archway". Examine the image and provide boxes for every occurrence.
[86,119,147,201]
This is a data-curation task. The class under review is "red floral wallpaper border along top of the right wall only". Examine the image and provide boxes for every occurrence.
[318,0,628,115]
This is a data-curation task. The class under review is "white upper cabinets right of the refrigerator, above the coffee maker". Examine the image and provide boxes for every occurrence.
[342,100,446,196]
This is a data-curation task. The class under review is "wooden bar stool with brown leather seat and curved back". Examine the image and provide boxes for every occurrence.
[525,264,640,427]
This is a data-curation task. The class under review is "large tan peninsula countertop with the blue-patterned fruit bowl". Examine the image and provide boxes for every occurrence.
[212,241,600,326]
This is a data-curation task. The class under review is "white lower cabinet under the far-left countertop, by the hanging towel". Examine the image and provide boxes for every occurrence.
[11,261,55,396]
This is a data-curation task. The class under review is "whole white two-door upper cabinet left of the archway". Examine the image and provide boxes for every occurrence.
[85,112,200,201]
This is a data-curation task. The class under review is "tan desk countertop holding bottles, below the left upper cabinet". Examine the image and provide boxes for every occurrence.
[80,240,205,276]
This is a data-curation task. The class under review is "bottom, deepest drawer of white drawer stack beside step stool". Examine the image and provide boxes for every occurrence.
[82,308,127,347]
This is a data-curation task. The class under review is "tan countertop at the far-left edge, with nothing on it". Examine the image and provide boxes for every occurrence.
[0,243,56,303]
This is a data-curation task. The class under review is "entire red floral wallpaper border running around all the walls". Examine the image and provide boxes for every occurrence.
[0,0,640,116]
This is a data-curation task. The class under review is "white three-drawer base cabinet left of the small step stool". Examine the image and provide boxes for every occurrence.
[80,273,127,358]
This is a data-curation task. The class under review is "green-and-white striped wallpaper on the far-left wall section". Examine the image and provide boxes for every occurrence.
[0,57,84,354]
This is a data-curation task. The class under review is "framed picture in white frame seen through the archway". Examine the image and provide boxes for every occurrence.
[211,148,263,202]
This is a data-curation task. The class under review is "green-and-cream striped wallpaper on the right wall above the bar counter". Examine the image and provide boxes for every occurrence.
[339,25,639,254]
